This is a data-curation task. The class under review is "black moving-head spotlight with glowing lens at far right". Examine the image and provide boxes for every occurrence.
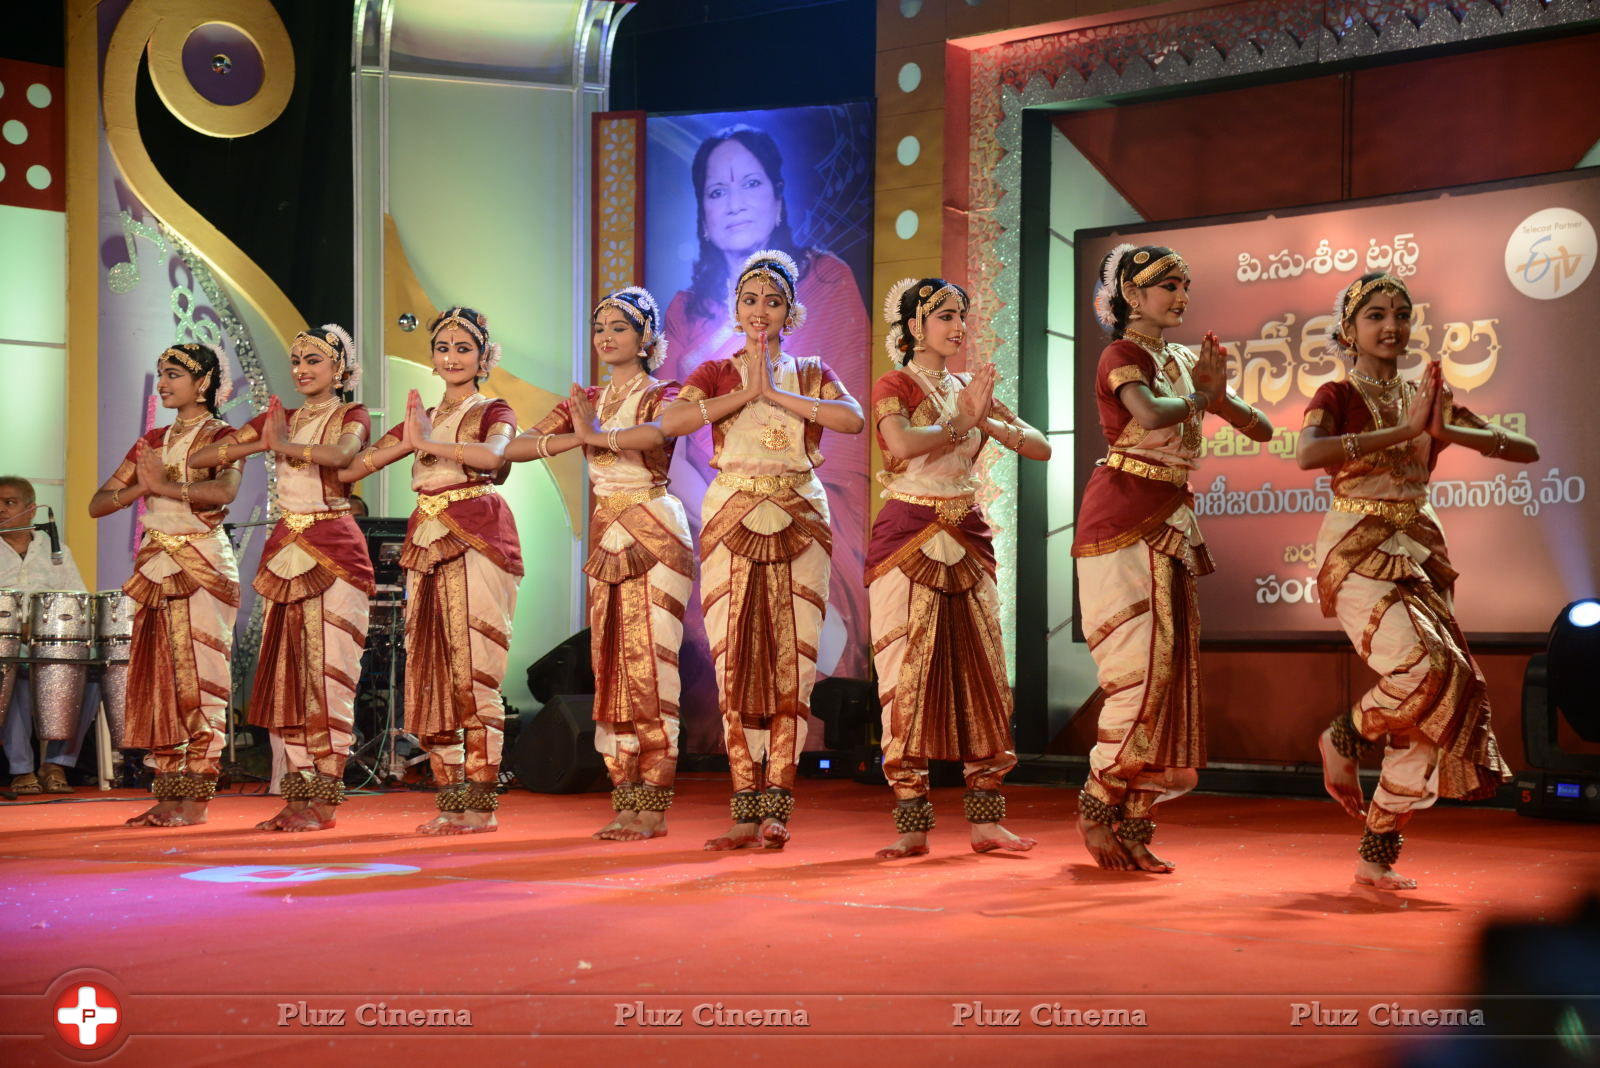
[1517,598,1600,820]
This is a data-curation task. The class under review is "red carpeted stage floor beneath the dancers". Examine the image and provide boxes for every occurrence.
[0,775,1600,1068]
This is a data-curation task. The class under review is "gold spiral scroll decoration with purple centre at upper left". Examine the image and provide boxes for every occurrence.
[101,0,306,349]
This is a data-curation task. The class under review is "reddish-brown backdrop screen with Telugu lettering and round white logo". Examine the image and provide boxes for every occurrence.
[1075,171,1600,641]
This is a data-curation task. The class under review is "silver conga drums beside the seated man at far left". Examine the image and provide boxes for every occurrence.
[0,590,136,790]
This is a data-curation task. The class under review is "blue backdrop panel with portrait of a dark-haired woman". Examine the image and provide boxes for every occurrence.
[645,104,872,751]
